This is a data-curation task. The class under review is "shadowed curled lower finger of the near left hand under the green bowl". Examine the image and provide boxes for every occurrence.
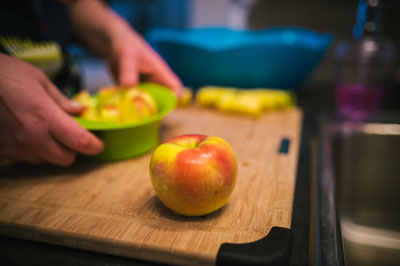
[39,136,76,166]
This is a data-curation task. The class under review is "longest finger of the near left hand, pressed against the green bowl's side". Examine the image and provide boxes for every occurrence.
[50,108,104,155]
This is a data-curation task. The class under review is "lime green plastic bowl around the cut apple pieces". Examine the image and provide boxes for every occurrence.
[74,83,177,161]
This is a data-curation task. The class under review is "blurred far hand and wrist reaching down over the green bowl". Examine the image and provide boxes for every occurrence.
[69,0,183,96]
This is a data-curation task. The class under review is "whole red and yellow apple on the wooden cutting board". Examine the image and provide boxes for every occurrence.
[150,134,238,216]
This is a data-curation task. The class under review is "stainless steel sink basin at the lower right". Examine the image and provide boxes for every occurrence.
[319,117,400,266]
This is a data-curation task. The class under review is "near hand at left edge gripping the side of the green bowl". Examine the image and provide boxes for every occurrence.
[0,54,103,166]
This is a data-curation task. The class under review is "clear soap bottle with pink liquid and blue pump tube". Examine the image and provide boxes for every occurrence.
[335,0,396,121]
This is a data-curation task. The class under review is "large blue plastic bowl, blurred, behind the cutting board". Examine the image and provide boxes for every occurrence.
[147,27,333,89]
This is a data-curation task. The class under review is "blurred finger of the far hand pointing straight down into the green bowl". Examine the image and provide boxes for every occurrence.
[118,52,139,87]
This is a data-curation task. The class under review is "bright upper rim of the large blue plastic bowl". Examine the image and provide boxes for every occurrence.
[146,26,333,52]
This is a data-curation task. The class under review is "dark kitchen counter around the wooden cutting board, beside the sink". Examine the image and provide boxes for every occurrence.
[0,76,400,266]
